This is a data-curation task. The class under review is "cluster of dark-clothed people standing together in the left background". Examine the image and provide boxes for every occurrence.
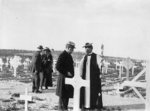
[31,45,53,93]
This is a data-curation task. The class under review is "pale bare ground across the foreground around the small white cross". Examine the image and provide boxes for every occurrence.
[0,80,145,111]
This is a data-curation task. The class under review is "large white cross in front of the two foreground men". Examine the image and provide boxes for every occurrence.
[65,74,89,111]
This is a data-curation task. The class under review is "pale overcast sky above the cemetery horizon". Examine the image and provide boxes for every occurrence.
[0,0,150,59]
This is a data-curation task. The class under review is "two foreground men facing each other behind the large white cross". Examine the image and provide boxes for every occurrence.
[56,41,103,111]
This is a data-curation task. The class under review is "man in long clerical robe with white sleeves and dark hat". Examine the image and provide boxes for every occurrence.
[80,43,103,110]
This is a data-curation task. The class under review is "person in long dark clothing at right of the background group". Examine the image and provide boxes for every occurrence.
[43,47,53,89]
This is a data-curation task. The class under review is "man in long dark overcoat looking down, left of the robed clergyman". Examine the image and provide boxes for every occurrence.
[56,41,75,110]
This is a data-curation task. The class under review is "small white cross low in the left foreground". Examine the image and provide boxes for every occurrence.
[20,88,32,111]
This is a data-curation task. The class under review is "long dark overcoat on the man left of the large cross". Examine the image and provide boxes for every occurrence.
[56,50,74,107]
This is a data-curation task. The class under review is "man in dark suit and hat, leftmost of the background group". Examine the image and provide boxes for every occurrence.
[31,45,43,93]
